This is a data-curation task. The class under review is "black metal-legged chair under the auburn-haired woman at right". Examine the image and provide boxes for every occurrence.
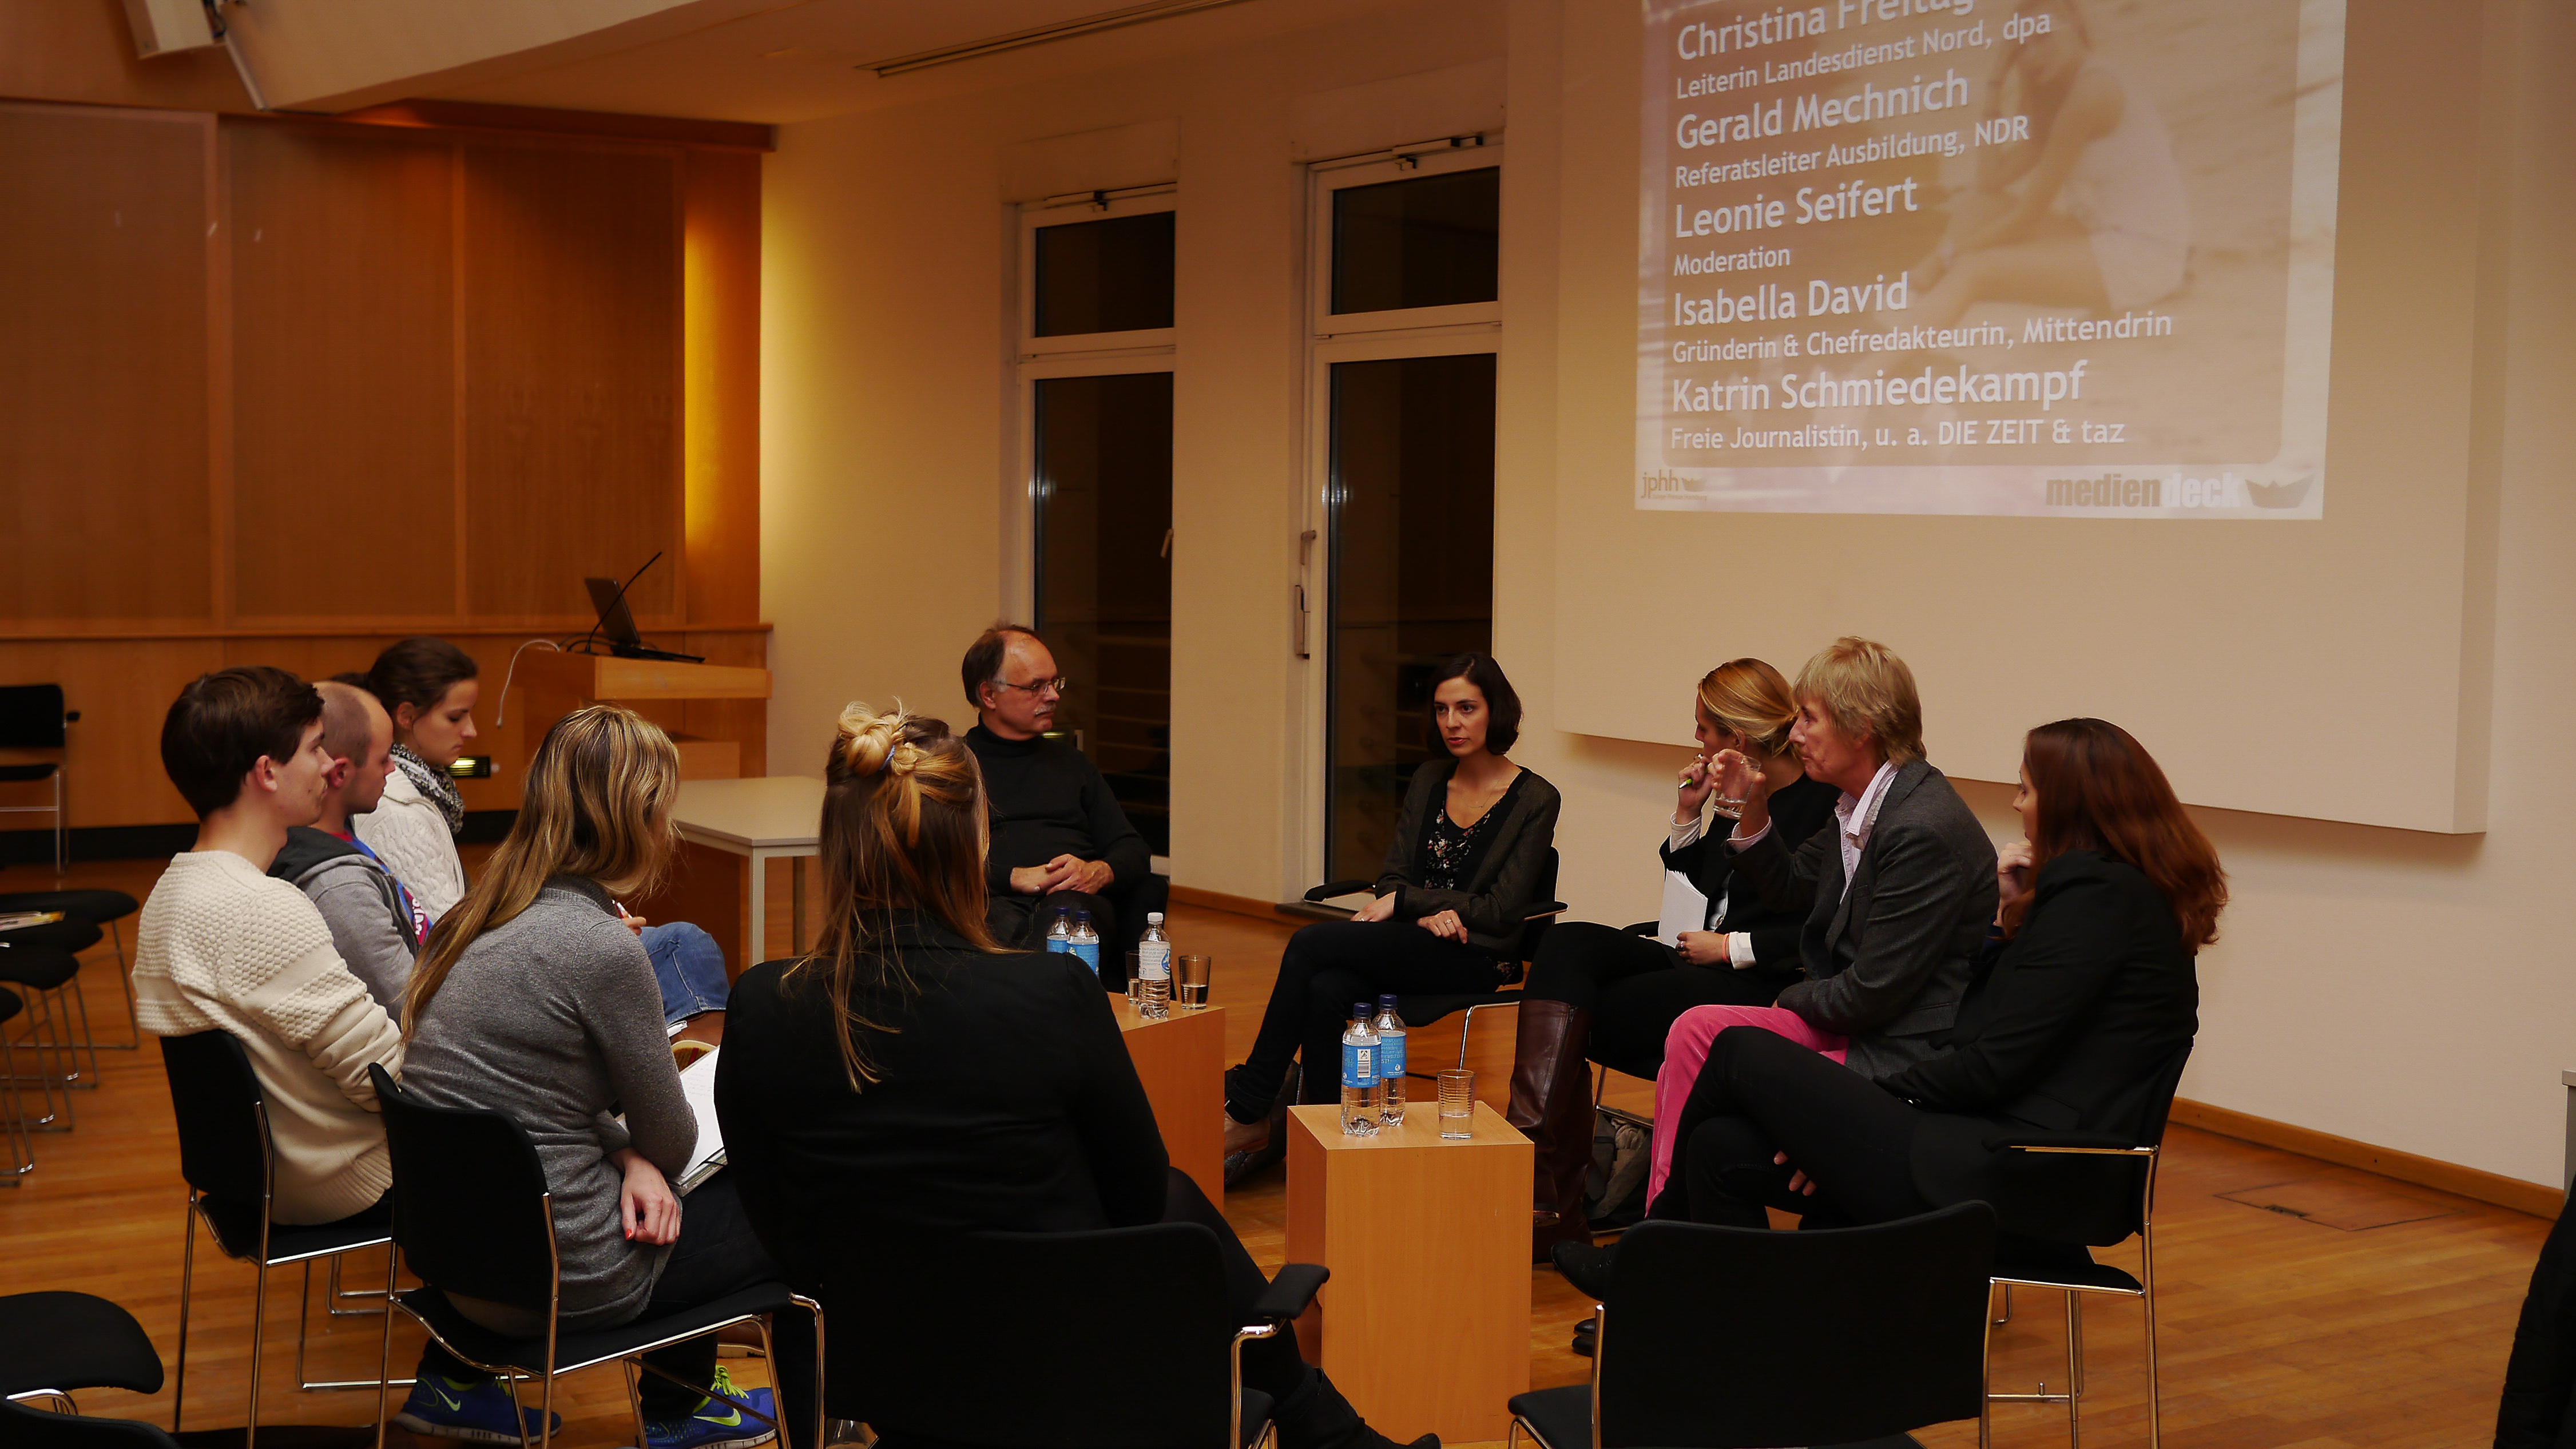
[1986,1045,2192,1449]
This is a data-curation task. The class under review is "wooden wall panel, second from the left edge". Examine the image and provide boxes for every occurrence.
[224,118,459,620]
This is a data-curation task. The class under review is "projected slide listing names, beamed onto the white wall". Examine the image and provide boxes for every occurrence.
[1636,0,2344,517]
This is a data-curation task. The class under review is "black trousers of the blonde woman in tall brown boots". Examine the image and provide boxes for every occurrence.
[1522,922,1798,1076]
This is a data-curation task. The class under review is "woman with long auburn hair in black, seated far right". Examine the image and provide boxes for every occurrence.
[1556,718,2228,1284]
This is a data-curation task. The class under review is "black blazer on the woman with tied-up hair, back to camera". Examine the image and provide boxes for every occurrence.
[716,919,1169,1289]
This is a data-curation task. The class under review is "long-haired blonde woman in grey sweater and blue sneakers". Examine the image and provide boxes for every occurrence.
[402,705,814,1449]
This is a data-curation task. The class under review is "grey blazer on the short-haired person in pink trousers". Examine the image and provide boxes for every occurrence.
[1736,759,1997,1081]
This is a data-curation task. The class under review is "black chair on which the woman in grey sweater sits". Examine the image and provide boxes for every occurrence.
[366,1066,824,1447]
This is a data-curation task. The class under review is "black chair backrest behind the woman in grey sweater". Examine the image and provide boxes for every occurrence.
[366,1066,554,1313]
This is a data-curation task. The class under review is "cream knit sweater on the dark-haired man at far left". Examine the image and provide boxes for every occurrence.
[134,849,402,1222]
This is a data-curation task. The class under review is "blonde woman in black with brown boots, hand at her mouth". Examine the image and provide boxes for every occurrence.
[1510,659,1834,1261]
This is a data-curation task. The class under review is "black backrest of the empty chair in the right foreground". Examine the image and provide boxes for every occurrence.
[1594,1202,1994,1449]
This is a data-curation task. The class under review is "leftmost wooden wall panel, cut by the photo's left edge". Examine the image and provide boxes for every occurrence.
[0,105,214,623]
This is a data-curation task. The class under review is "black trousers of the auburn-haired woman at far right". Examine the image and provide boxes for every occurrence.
[1649,1027,1935,1228]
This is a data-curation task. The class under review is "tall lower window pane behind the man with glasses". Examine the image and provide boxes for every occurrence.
[1033,373,1172,855]
